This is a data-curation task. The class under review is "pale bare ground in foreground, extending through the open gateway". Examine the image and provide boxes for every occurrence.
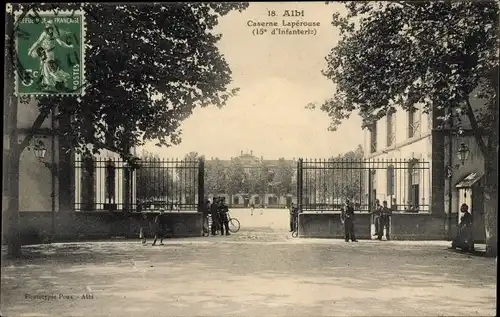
[1,210,496,317]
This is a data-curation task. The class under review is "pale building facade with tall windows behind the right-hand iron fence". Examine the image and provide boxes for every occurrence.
[364,106,433,212]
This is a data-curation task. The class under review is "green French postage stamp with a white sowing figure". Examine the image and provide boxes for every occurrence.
[14,10,85,96]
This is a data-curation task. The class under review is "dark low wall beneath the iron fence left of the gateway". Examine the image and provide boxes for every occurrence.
[2,211,203,244]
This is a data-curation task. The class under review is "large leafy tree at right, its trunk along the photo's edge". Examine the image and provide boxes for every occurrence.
[312,1,499,255]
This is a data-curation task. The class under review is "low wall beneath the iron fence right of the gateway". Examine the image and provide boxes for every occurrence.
[298,212,457,240]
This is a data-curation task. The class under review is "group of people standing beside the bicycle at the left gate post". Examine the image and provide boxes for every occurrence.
[203,197,230,236]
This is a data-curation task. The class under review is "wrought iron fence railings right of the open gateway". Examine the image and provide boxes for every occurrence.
[297,159,430,212]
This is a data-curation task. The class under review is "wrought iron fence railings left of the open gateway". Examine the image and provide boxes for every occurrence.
[75,158,204,211]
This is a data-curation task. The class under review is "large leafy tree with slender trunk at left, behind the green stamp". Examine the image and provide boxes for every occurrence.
[4,2,248,255]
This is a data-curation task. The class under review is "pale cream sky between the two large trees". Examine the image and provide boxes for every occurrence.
[139,2,363,159]
